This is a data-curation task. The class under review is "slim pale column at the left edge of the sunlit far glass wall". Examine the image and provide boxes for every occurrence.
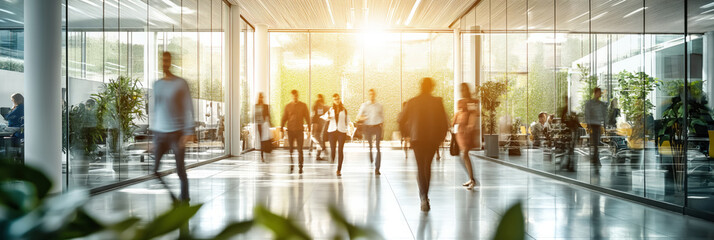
[255,24,268,96]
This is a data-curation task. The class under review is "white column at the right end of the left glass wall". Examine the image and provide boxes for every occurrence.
[231,5,243,156]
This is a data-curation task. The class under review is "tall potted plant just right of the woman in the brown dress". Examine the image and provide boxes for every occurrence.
[476,81,507,157]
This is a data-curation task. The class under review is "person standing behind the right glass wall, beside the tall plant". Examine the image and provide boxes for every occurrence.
[584,87,607,173]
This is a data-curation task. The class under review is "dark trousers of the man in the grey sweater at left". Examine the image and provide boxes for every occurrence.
[154,131,189,200]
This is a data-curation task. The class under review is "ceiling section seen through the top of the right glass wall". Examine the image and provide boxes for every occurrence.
[461,0,714,34]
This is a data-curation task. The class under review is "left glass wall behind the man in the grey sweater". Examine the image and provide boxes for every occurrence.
[61,0,229,189]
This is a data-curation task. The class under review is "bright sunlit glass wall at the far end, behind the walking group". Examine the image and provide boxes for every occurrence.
[270,31,454,140]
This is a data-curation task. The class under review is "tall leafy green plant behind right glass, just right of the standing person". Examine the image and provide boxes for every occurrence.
[617,71,658,149]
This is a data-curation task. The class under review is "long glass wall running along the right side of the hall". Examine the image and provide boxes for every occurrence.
[459,0,714,218]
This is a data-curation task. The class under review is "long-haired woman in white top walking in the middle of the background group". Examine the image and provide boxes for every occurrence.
[322,93,350,176]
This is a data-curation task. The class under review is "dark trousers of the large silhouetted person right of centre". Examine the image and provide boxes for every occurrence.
[411,141,439,201]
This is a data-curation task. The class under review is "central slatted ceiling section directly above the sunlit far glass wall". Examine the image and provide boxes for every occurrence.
[239,0,476,29]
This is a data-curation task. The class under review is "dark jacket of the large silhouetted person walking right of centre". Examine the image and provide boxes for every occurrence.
[399,94,449,146]
